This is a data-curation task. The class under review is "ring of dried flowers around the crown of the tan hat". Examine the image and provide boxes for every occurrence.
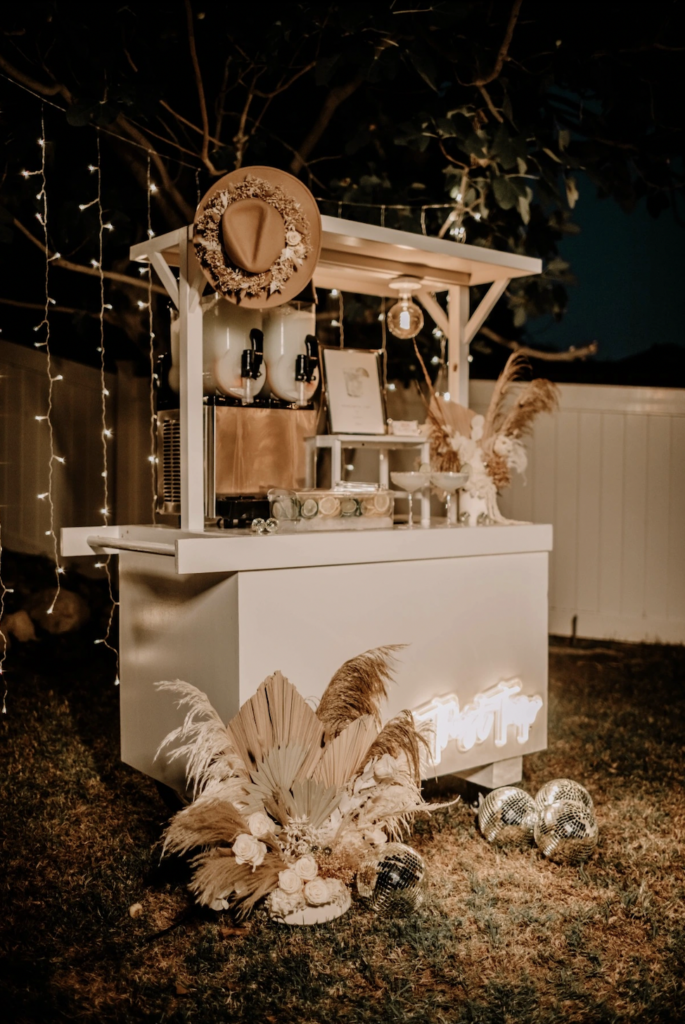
[194,174,312,298]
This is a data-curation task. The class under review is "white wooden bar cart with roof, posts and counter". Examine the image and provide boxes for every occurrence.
[62,217,552,790]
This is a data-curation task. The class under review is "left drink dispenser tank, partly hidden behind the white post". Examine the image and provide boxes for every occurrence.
[169,293,266,406]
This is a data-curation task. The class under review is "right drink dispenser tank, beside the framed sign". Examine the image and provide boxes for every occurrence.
[264,302,319,407]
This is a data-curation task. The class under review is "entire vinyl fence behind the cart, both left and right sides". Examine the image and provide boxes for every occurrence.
[0,342,685,643]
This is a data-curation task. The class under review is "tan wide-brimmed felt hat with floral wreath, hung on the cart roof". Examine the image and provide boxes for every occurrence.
[194,167,322,309]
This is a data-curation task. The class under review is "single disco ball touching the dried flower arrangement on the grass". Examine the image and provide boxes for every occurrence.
[356,843,426,916]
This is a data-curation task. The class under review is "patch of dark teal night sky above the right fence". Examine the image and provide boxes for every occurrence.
[528,176,685,359]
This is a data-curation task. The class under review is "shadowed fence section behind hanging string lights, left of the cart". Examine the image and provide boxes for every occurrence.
[0,341,152,555]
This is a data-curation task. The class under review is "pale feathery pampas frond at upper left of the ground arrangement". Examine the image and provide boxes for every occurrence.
[155,679,243,797]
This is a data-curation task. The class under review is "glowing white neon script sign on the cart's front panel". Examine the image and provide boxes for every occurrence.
[414,679,543,765]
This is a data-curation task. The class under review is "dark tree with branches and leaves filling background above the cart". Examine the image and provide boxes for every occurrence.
[0,0,684,379]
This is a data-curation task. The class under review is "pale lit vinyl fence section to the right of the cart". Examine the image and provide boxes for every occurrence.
[471,381,685,643]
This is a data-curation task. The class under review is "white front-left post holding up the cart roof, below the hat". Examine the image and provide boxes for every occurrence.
[178,238,205,534]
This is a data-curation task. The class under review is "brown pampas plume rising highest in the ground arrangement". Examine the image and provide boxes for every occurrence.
[316,644,406,736]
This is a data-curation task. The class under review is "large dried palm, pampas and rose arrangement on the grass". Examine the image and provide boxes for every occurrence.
[157,644,454,923]
